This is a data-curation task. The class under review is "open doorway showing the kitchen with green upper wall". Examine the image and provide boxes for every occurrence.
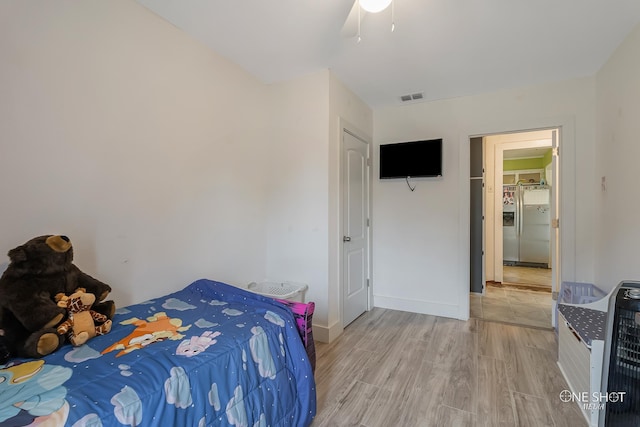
[470,129,560,328]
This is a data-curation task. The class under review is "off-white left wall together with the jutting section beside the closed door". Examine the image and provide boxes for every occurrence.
[0,0,373,340]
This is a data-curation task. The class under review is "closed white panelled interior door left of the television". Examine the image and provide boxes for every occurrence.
[342,129,369,327]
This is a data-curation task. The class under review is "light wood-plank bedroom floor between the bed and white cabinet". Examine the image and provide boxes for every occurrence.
[312,308,587,427]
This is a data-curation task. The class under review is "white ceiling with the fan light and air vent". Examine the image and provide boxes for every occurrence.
[137,0,640,108]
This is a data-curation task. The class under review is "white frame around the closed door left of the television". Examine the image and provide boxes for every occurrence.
[338,119,374,329]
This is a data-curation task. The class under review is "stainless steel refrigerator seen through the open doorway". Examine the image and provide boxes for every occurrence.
[502,185,551,268]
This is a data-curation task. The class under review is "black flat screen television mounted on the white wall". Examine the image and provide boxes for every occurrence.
[380,138,442,179]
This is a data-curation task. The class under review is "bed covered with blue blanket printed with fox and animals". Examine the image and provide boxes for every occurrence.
[0,279,316,427]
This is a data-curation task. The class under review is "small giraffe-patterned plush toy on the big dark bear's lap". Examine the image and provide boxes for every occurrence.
[56,288,111,347]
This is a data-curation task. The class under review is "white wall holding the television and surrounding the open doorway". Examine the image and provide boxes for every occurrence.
[373,78,595,318]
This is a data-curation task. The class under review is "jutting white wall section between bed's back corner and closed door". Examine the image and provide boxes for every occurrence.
[266,70,373,341]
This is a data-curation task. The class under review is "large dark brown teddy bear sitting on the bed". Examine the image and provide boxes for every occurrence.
[0,235,115,357]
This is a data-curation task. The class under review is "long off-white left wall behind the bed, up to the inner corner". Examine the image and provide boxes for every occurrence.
[0,0,270,306]
